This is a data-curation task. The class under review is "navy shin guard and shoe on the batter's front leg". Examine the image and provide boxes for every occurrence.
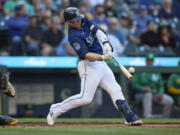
[116,100,142,125]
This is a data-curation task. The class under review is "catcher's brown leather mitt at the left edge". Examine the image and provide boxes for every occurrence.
[0,76,15,97]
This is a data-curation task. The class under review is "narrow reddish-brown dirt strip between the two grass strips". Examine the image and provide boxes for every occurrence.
[0,124,180,128]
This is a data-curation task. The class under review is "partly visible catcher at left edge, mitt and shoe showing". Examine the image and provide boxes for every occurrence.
[0,73,18,126]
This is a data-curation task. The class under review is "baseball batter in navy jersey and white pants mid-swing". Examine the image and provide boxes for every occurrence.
[47,7,142,125]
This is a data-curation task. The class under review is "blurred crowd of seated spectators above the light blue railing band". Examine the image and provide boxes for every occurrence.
[0,0,180,57]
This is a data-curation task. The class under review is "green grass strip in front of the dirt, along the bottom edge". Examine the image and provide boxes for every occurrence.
[0,127,180,135]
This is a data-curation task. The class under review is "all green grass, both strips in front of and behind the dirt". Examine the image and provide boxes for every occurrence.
[0,118,180,135]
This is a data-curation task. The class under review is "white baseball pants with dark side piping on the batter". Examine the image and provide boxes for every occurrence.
[51,60,125,117]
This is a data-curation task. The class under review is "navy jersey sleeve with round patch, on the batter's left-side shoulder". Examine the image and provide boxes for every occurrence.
[69,37,88,59]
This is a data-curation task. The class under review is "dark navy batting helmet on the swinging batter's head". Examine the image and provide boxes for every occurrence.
[64,7,84,22]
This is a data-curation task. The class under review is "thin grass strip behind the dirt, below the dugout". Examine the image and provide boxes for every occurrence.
[18,118,180,124]
